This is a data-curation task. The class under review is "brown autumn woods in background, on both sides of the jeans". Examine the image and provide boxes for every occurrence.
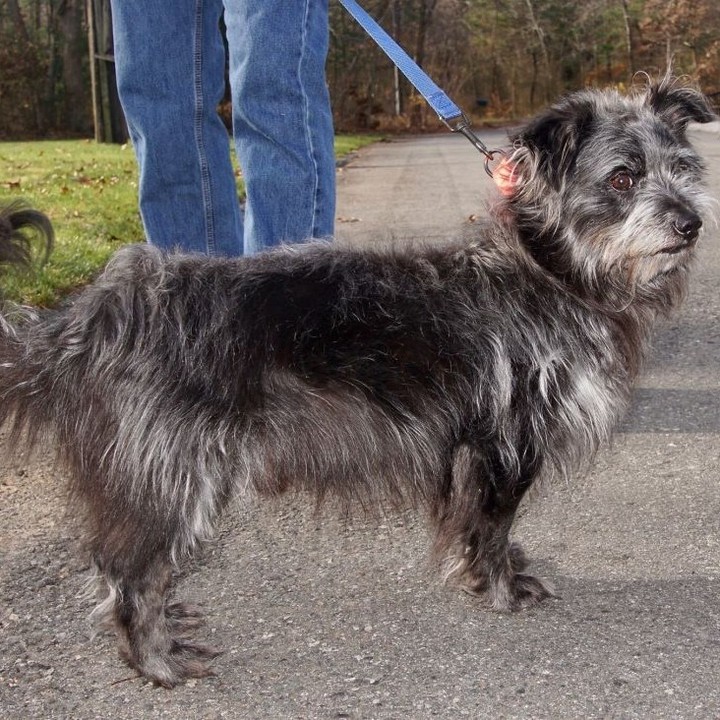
[0,0,720,139]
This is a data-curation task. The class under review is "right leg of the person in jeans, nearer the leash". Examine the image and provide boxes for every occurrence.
[224,0,335,254]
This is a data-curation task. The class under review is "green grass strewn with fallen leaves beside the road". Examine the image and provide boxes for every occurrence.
[0,135,378,306]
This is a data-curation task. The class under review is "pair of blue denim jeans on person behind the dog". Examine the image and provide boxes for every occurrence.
[112,0,335,256]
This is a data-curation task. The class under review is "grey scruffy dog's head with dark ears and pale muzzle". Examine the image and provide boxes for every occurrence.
[503,79,715,302]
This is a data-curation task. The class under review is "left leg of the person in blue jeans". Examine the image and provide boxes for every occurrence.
[112,0,243,255]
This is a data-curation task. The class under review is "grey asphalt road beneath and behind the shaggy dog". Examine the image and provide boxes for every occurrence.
[0,128,720,720]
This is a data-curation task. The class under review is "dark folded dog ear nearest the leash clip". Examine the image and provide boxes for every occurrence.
[512,98,594,193]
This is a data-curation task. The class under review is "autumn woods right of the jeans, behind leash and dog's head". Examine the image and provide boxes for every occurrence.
[329,0,720,127]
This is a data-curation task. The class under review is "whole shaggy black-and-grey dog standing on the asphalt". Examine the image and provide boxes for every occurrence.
[0,81,713,686]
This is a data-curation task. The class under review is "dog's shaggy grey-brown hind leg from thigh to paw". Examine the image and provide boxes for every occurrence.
[60,404,232,687]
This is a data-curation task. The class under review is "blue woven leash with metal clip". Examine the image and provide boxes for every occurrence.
[340,0,502,177]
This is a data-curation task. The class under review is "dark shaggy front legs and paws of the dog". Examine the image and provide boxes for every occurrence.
[435,444,554,610]
